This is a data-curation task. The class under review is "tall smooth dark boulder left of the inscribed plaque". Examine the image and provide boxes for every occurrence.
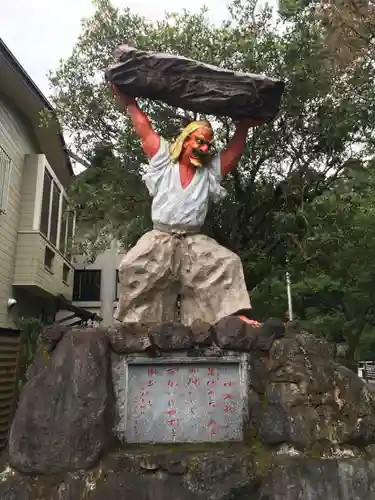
[9,328,113,474]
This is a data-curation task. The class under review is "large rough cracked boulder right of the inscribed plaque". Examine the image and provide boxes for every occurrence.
[249,333,375,449]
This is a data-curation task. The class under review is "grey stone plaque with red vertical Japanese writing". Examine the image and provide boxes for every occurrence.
[125,361,244,443]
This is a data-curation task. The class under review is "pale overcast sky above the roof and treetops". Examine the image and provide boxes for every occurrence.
[0,0,229,97]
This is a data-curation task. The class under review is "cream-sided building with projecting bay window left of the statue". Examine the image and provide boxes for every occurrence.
[0,39,74,329]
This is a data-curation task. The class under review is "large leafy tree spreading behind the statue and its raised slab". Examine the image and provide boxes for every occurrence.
[51,0,375,360]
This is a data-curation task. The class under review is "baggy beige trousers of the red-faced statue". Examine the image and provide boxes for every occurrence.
[115,230,251,325]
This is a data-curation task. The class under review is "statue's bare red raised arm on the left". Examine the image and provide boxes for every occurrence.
[112,85,160,159]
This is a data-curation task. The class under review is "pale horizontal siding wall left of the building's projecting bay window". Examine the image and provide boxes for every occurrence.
[0,96,36,327]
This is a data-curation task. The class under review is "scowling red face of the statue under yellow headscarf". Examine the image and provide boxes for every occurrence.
[181,127,214,167]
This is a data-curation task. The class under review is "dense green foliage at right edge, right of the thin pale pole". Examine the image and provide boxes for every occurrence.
[255,163,375,362]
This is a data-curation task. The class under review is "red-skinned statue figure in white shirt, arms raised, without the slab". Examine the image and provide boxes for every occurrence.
[112,86,261,326]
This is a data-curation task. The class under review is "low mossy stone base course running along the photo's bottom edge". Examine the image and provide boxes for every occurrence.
[0,448,375,500]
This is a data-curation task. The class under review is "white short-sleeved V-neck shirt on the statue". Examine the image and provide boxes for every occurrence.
[142,138,226,227]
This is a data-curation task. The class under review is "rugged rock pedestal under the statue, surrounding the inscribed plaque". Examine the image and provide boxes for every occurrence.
[0,317,375,500]
